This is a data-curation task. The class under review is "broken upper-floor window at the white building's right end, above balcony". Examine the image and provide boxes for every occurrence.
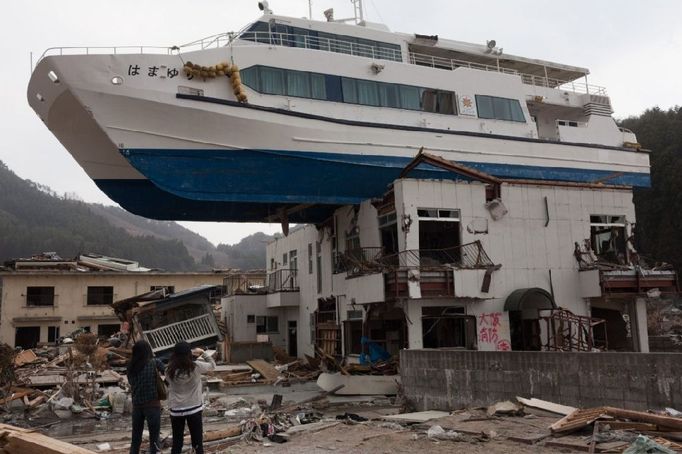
[590,215,627,264]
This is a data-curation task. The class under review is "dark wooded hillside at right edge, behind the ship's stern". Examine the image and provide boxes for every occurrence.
[621,106,682,273]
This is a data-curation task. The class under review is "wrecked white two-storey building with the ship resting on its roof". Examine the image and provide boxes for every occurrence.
[223,153,677,361]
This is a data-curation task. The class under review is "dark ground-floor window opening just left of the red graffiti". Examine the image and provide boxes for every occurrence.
[422,307,476,350]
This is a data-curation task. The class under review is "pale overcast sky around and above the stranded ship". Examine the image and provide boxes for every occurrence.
[0,0,682,244]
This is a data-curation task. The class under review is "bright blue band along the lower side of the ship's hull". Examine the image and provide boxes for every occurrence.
[121,149,650,205]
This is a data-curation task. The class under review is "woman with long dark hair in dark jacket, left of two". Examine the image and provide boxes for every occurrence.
[128,340,161,454]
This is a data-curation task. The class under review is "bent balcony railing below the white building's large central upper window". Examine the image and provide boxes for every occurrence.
[381,241,495,269]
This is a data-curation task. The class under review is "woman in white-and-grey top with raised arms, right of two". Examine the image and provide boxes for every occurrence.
[166,341,215,454]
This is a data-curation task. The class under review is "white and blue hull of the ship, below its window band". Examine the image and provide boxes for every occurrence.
[29,26,649,222]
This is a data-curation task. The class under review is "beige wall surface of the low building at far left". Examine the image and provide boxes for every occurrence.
[0,272,224,346]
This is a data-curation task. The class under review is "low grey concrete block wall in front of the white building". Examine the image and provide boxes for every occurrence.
[400,350,682,410]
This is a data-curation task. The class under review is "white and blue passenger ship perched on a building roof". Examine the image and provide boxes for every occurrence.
[28,0,650,223]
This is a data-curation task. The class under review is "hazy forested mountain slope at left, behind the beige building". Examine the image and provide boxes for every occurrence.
[0,161,267,271]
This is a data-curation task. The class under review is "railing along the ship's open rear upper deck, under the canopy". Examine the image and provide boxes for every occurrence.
[408,52,608,96]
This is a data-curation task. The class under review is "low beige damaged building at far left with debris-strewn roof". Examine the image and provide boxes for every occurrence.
[0,253,264,348]
